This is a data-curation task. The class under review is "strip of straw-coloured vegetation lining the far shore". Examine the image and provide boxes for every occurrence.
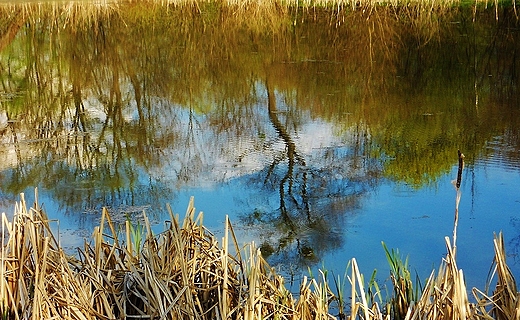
[0,0,518,23]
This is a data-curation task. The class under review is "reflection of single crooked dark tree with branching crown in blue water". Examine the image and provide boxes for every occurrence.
[236,76,380,267]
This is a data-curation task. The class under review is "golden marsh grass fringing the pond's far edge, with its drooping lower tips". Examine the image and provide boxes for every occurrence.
[0,0,516,34]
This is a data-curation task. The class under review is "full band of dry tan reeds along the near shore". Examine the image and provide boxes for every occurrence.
[0,190,520,320]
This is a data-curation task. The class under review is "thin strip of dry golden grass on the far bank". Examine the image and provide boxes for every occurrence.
[0,0,516,18]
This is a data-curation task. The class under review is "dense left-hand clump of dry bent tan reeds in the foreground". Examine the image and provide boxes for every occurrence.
[0,194,330,319]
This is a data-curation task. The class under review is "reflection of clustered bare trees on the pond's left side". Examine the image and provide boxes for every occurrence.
[1,11,176,220]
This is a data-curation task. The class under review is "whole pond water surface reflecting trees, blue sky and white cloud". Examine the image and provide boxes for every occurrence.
[0,0,520,296]
